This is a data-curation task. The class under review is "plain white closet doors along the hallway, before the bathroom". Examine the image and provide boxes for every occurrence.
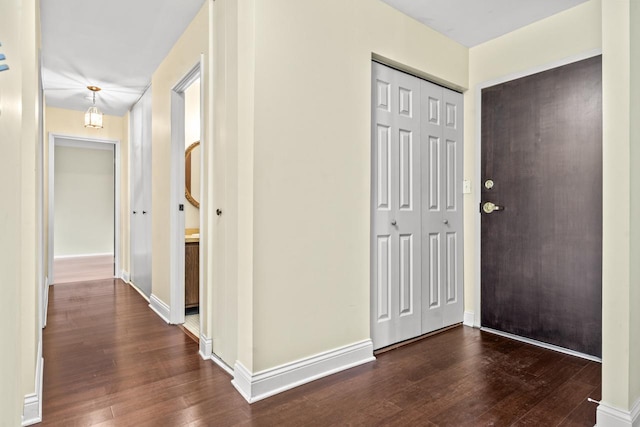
[130,88,151,296]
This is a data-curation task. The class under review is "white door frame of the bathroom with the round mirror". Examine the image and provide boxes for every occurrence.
[169,59,204,328]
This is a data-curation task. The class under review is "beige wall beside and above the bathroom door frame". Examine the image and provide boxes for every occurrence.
[151,2,209,305]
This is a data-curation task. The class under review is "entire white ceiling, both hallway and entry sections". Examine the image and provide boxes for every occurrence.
[41,0,586,116]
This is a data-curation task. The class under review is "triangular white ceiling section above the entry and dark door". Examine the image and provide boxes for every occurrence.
[382,0,587,47]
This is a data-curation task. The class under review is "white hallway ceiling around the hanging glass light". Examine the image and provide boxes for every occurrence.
[41,0,204,116]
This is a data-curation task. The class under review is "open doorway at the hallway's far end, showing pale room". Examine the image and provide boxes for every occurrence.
[47,134,120,284]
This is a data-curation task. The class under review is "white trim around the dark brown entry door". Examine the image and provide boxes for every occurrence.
[471,49,602,328]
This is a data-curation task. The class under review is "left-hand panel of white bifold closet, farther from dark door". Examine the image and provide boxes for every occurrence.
[371,63,422,348]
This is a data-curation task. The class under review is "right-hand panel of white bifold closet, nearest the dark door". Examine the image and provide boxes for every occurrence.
[421,81,464,334]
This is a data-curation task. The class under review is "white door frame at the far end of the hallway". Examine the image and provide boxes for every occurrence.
[47,132,122,284]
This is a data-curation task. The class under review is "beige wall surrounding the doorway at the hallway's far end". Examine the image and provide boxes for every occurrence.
[45,107,130,273]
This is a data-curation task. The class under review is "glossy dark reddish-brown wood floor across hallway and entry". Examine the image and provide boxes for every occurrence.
[43,279,601,427]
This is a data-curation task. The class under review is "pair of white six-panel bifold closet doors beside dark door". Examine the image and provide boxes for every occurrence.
[371,63,463,349]
